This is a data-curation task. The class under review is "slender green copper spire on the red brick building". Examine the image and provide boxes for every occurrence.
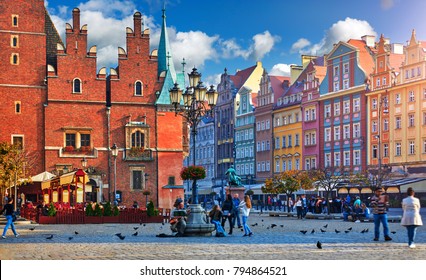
[158,4,176,82]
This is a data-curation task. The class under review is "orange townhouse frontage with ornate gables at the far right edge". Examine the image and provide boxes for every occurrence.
[367,30,426,177]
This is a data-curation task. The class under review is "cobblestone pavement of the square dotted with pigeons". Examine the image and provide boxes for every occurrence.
[0,213,426,260]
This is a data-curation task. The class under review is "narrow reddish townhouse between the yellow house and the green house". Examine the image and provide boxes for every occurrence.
[301,56,327,170]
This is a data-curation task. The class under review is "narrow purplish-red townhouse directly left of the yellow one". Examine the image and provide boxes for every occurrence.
[255,71,290,183]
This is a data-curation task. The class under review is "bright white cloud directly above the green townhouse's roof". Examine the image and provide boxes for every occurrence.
[292,17,377,55]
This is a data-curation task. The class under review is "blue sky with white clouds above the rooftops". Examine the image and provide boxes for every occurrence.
[45,0,426,85]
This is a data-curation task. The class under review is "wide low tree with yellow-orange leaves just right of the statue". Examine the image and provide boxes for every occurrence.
[262,170,312,212]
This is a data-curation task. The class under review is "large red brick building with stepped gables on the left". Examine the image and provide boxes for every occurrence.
[0,0,183,208]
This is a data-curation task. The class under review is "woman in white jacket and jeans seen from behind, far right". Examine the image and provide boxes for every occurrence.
[401,188,423,249]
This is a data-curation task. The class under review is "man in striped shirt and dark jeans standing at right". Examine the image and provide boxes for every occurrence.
[370,187,392,241]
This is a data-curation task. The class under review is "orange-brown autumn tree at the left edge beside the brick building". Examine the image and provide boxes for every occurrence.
[0,142,34,209]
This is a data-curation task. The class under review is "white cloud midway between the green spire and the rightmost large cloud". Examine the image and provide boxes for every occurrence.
[220,30,281,61]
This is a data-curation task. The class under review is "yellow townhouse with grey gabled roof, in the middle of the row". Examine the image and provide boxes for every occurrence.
[272,71,303,174]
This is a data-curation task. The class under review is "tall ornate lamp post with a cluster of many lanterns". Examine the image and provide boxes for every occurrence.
[170,68,218,235]
